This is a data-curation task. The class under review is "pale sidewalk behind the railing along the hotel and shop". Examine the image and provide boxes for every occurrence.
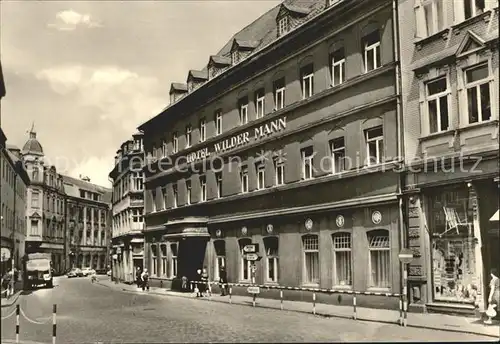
[97,280,500,338]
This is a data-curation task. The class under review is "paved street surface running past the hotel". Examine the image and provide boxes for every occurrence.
[1,276,494,343]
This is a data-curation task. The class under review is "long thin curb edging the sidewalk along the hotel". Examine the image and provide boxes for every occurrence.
[94,283,500,339]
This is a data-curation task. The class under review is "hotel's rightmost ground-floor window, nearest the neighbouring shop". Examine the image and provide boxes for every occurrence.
[368,230,391,288]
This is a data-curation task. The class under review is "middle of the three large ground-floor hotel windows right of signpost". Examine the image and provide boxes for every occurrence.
[332,233,352,286]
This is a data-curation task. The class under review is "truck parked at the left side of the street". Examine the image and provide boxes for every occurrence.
[24,253,54,289]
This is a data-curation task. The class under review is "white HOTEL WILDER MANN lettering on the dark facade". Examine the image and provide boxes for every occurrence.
[186,116,286,164]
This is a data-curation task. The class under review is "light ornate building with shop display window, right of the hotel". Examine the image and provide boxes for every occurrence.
[398,0,500,313]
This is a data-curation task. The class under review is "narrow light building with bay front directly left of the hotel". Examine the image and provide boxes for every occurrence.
[109,133,144,283]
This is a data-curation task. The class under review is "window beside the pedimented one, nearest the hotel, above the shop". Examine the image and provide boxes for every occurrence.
[426,77,450,134]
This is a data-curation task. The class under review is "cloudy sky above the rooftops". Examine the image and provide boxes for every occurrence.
[0,0,280,186]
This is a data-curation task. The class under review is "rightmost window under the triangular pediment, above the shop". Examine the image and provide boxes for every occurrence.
[465,63,491,124]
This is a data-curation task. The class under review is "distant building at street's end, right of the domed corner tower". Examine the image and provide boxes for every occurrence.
[63,176,111,271]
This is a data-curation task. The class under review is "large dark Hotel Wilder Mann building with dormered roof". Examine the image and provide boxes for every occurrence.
[139,0,401,307]
